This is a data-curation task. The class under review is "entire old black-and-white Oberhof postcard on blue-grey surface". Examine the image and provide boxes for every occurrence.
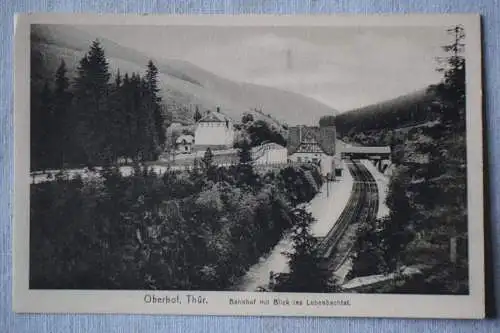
[13,14,485,318]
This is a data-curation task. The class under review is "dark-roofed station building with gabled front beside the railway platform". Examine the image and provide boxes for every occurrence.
[287,126,339,175]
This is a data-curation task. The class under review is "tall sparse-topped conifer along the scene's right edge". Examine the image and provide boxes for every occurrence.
[429,25,467,278]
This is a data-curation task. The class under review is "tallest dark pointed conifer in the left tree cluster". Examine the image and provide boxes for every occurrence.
[73,40,111,165]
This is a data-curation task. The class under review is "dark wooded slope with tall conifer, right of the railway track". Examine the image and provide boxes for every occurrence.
[348,26,468,294]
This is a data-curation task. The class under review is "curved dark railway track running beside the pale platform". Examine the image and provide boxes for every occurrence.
[318,160,379,271]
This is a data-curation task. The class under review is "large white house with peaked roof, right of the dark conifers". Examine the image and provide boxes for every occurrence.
[193,107,235,151]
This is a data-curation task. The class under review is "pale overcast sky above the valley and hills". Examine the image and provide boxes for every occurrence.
[79,26,449,111]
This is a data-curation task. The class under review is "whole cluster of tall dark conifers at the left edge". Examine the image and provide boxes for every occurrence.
[31,40,165,170]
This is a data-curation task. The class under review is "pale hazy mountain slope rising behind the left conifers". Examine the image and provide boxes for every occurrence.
[31,25,337,125]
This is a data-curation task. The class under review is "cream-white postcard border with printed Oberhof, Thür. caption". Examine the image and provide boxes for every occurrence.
[12,13,487,318]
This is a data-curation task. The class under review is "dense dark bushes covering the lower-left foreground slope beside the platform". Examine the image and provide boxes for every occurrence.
[30,157,321,290]
